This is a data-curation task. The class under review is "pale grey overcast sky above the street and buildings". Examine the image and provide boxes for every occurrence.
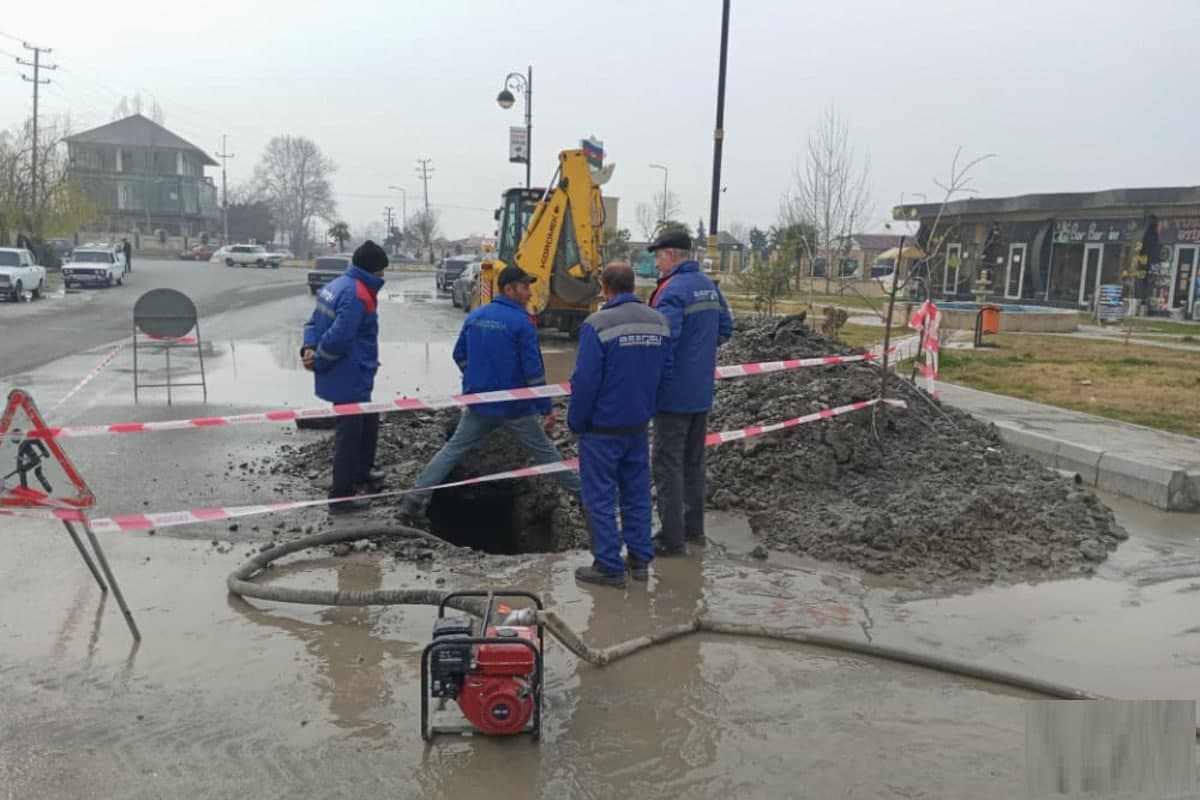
[0,0,1200,237]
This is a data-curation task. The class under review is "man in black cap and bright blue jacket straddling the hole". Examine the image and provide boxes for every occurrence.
[404,266,580,518]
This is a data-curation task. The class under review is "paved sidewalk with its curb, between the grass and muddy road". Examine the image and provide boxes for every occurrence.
[938,384,1200,511]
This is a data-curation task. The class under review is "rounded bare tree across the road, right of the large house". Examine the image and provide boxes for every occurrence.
[254,136,337,253]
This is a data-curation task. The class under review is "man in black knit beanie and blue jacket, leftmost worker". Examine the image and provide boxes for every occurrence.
[300,241,388,513]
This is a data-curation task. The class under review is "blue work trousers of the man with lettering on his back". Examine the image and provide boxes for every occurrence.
[580,431,654,575]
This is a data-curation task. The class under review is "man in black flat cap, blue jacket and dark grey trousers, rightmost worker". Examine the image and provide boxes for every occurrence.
[649,230,733,555]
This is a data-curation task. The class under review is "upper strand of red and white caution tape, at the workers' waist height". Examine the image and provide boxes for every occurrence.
[14,344,899,439]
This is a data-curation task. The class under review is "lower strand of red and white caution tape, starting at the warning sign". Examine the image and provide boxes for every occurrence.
[0,398,905,533]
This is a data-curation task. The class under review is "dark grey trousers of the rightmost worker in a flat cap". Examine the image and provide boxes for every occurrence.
[654,411,708,547]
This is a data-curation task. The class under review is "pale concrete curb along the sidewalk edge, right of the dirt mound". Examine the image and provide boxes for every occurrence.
[976,415,1200,511]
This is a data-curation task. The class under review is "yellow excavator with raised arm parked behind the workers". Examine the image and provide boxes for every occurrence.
[472,150,613,338]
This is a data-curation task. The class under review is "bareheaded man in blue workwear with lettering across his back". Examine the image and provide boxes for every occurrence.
[566,264,671,587]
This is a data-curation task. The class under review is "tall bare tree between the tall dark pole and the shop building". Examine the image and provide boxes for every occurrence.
[782,106,871,291]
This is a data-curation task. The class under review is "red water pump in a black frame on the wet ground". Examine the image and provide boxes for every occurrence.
[421,589,544,741]
